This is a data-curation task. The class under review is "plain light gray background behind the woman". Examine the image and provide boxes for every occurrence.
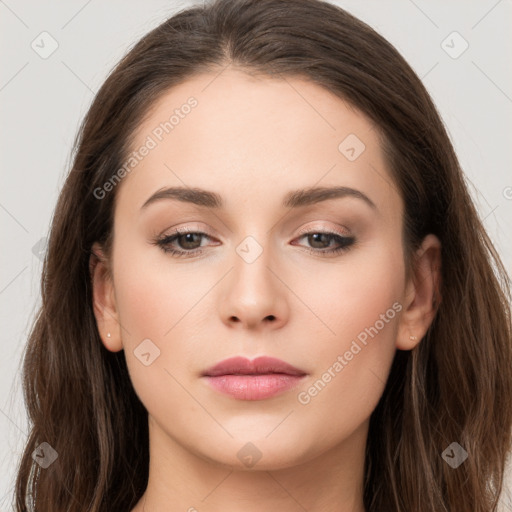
[0,0,512,512]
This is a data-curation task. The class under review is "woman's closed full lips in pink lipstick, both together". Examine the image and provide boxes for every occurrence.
[203,356,306,400]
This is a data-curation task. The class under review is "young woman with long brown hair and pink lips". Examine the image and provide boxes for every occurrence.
[16,0,512,512]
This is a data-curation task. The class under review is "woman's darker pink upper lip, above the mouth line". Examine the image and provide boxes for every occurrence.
[203,356,306,377]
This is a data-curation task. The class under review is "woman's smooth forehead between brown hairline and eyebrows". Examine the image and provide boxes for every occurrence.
[117,67,401,218]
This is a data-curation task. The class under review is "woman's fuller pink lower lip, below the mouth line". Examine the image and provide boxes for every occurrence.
[206,373,304,400]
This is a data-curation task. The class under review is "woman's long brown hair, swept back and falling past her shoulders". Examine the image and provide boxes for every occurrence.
[16,0,512,512]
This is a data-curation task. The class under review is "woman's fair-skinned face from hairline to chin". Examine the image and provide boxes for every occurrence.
[91,69,436,469]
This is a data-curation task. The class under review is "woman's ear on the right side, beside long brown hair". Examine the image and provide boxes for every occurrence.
[396,234,441,350]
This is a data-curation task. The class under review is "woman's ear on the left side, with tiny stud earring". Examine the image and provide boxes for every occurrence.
[89,242,123,352]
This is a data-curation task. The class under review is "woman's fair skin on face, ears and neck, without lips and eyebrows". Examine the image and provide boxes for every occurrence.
[91,68,440,512]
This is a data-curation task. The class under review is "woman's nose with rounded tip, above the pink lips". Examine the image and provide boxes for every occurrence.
[219,238,288,330]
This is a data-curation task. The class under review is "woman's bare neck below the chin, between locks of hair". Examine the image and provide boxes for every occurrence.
[132,421,368,512]
